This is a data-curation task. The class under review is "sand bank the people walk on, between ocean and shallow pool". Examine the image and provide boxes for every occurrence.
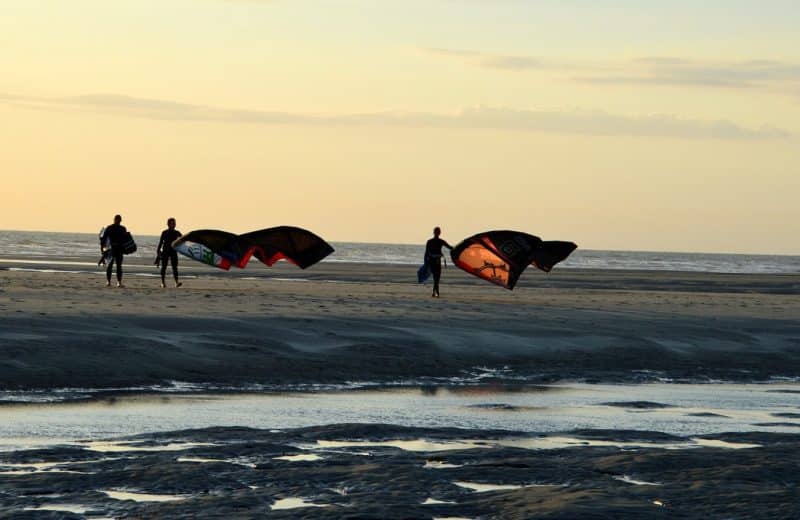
[0,259,800,389]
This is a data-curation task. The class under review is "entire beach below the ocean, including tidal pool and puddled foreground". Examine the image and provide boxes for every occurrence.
[0,257,800,518]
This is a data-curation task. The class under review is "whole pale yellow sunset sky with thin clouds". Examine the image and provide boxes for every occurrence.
[0,0,800,254]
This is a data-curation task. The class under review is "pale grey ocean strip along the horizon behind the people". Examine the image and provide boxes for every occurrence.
[0,231,800,274]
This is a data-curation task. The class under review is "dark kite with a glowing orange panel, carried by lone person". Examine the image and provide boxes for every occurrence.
[450,231,578,290]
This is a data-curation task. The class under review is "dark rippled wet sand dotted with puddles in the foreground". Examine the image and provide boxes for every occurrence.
[0,424,800,519]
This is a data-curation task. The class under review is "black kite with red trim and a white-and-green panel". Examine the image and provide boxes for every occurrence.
[172,226,333,270]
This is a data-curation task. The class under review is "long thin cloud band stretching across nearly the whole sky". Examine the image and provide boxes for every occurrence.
[0,94,790,140]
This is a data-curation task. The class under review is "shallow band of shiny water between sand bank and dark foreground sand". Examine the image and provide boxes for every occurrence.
[0,383,800,448]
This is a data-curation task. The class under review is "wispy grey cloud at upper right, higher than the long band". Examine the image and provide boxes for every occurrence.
[422,48,800,88]
